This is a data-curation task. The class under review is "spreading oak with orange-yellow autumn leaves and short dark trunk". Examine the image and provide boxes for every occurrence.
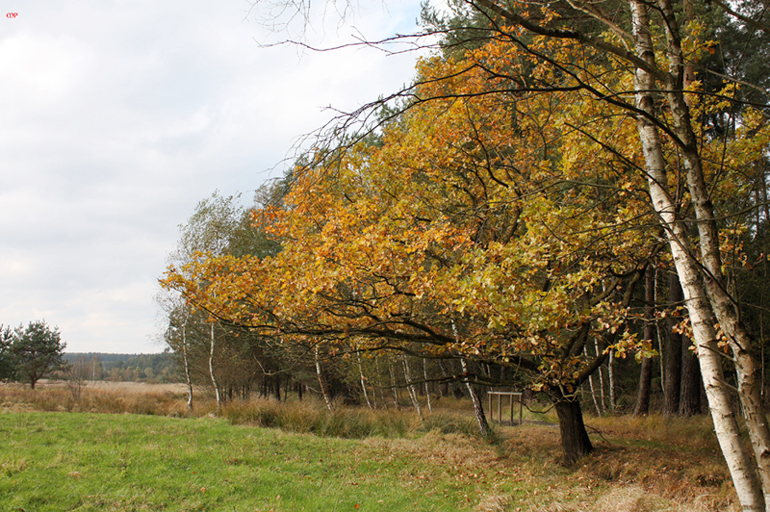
[165,34,660,462]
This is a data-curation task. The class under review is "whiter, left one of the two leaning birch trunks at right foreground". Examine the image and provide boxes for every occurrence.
[629,0,765,504]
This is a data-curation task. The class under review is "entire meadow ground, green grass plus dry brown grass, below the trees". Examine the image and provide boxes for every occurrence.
[0,384,739,512]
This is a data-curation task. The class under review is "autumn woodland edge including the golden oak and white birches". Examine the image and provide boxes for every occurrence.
[162,0,770,510]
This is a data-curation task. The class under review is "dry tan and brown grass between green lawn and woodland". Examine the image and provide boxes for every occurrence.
[0,383,739,512]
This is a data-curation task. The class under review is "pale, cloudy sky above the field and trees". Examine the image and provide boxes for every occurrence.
[0,0,426,353]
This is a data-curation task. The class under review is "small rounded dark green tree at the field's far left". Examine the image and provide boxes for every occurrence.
[11,321,67,389]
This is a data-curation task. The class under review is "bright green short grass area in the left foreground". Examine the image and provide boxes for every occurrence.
[0,413,528,512]
